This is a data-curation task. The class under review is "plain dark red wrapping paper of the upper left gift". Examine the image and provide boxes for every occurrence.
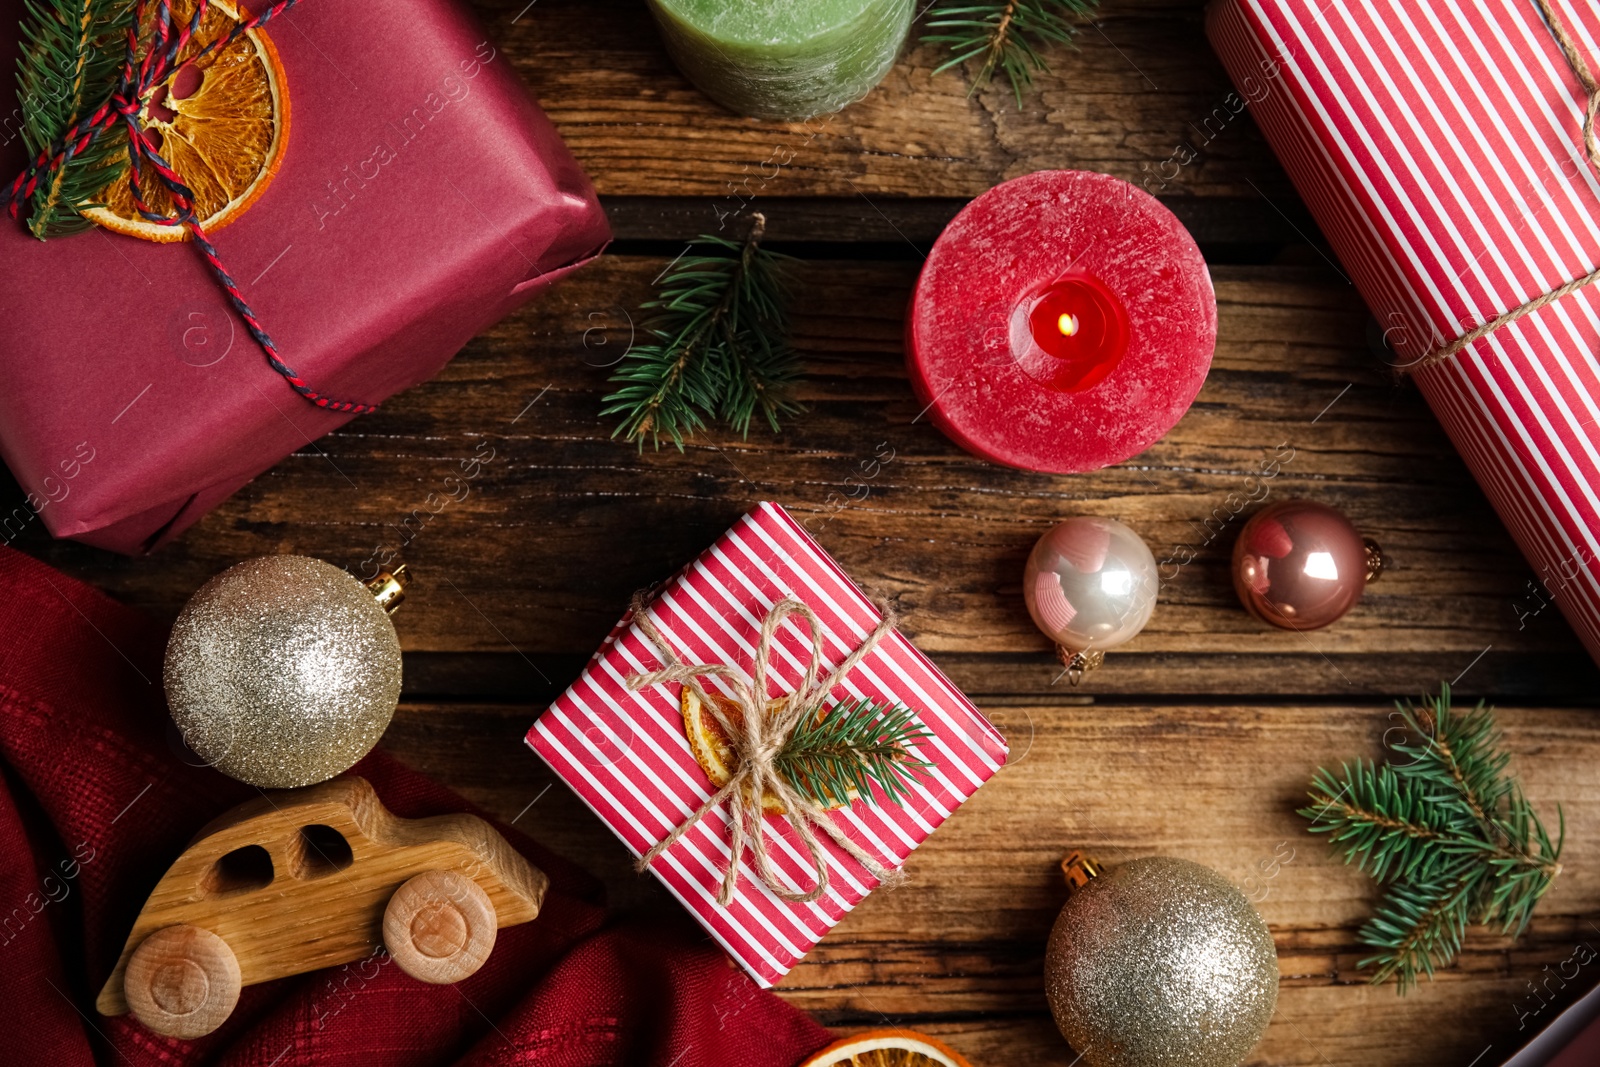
[0,0,610,552]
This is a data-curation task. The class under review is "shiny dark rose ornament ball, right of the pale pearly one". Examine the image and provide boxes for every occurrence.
[1234,501,1384,630]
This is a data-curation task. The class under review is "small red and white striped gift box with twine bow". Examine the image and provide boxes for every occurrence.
[528,504,1006,985]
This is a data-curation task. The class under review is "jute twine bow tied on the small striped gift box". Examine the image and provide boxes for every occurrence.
[627,595,899,907]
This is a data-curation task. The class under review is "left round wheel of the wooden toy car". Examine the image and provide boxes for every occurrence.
[123,923,243,1038]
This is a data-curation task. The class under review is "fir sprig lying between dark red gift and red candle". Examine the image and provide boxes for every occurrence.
[600,214,802,451]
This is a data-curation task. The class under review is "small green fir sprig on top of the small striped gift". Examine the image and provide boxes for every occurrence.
[773,697,933,808]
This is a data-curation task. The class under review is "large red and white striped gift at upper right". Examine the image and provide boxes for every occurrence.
[1208,0,1600,659]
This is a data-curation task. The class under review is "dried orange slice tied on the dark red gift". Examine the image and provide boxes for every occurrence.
[82,0,290,242]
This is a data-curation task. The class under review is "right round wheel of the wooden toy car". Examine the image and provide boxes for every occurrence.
[384,870,499,985]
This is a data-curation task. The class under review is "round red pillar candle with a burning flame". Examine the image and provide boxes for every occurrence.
[906,171,1216,474]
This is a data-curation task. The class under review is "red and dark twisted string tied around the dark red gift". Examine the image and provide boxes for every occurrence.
[0,0,378,414]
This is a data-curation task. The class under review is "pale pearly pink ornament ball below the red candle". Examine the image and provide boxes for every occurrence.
[1022,517,1160,685]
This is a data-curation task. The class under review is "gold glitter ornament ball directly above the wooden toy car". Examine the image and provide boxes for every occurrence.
[165,555,400,789]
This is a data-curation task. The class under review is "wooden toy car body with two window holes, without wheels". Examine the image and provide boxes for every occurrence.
[96,777,549,1017]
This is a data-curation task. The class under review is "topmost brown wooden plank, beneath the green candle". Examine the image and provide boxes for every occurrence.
[475,0,1293,208]
